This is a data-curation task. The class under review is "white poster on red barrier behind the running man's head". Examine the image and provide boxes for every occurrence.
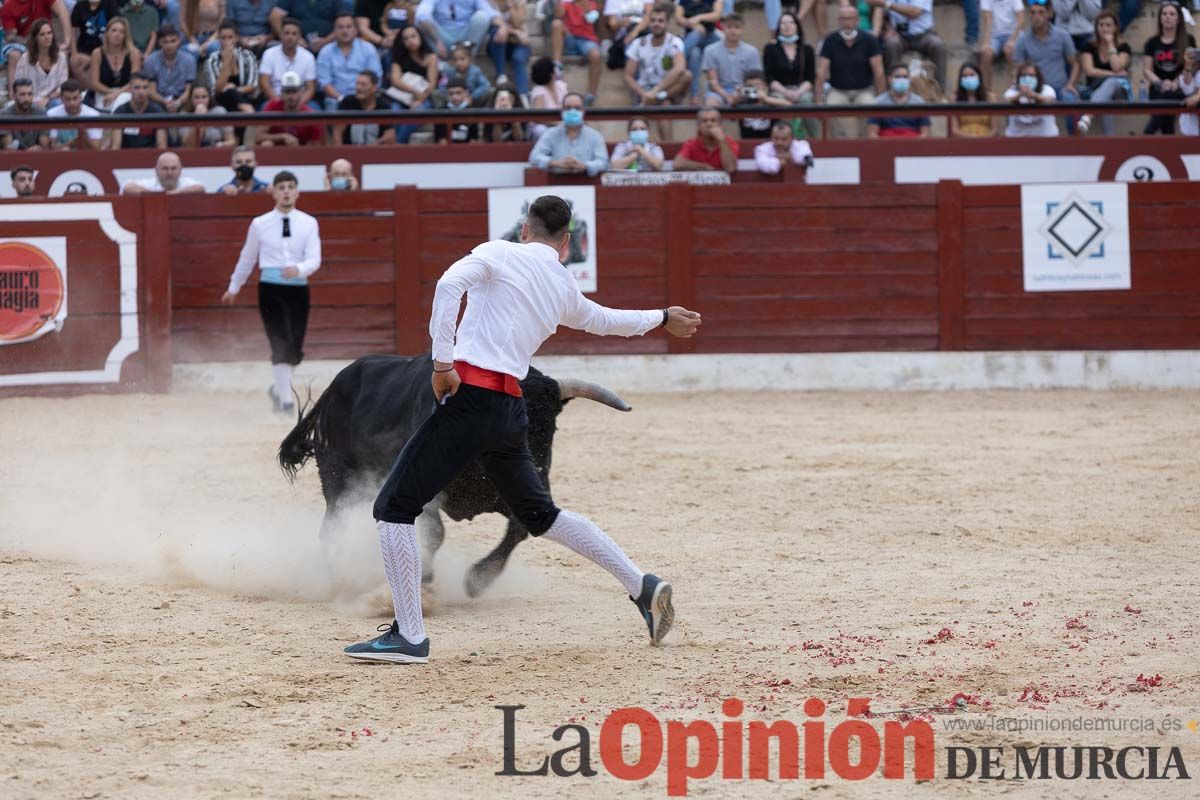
[487,186,596,293]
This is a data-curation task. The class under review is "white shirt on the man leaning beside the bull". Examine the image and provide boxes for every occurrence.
[430,240,662,379]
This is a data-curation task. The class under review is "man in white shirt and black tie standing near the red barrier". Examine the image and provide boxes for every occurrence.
[221,170,320,414]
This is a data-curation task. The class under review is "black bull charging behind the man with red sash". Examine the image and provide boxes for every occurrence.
[280,355,630,597]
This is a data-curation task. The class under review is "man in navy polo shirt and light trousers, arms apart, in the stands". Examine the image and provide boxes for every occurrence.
[812,6,887,139]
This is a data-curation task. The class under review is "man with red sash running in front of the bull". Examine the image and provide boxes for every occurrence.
[344,196,700,663]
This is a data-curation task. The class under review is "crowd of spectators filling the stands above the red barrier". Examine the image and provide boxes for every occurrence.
[0,0,1200,175]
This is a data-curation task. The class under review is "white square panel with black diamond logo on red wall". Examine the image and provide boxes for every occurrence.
[1021,184,1132,291]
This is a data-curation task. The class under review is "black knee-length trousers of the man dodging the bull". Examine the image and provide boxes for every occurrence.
[374,384,558,536]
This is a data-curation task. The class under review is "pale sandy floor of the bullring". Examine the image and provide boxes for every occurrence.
[0,390,1200,800]
